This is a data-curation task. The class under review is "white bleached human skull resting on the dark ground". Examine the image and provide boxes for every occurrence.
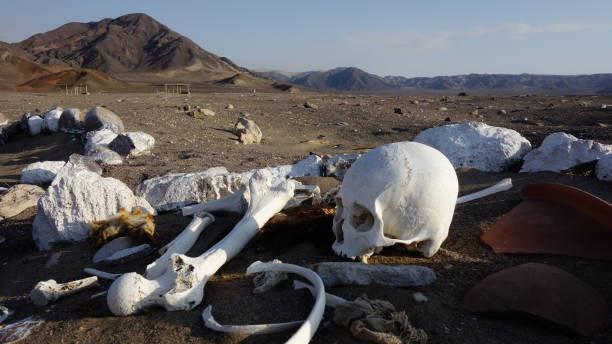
[332,142,459,259]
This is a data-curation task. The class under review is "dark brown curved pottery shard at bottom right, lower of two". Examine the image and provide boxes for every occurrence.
[464,263,607,336]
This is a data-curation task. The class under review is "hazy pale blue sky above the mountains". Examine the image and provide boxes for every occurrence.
[0,0,612,76]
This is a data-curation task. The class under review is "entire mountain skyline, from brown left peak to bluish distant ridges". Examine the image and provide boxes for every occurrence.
[0,13,612,94]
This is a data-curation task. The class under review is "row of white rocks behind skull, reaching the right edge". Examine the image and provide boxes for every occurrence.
[414,122,612,181]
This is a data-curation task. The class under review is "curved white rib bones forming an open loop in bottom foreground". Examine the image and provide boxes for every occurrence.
[202,262,325,344]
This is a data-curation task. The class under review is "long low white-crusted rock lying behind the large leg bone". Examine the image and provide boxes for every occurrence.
[136,155,322,211]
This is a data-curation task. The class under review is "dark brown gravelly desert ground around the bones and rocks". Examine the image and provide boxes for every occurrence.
[0,90,612,344]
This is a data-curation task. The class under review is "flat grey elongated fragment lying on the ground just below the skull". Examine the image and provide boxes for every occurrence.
[317,262,436,288]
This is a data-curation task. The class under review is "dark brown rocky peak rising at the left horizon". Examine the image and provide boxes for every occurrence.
[14,13,243,80]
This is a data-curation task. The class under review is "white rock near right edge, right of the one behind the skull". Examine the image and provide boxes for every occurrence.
[521,133,612,172]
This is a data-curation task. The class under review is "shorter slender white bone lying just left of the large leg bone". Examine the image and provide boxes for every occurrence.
[145,213,215,279]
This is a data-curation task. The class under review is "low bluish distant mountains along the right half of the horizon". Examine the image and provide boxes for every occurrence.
[255,67,612,94]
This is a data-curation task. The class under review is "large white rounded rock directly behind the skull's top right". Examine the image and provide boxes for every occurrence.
[414,122,531,172]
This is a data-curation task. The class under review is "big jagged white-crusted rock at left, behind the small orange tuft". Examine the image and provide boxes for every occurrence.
[32,162,154,250]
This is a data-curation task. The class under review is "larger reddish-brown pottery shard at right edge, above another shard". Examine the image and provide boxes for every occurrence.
[481,184,612,260]
